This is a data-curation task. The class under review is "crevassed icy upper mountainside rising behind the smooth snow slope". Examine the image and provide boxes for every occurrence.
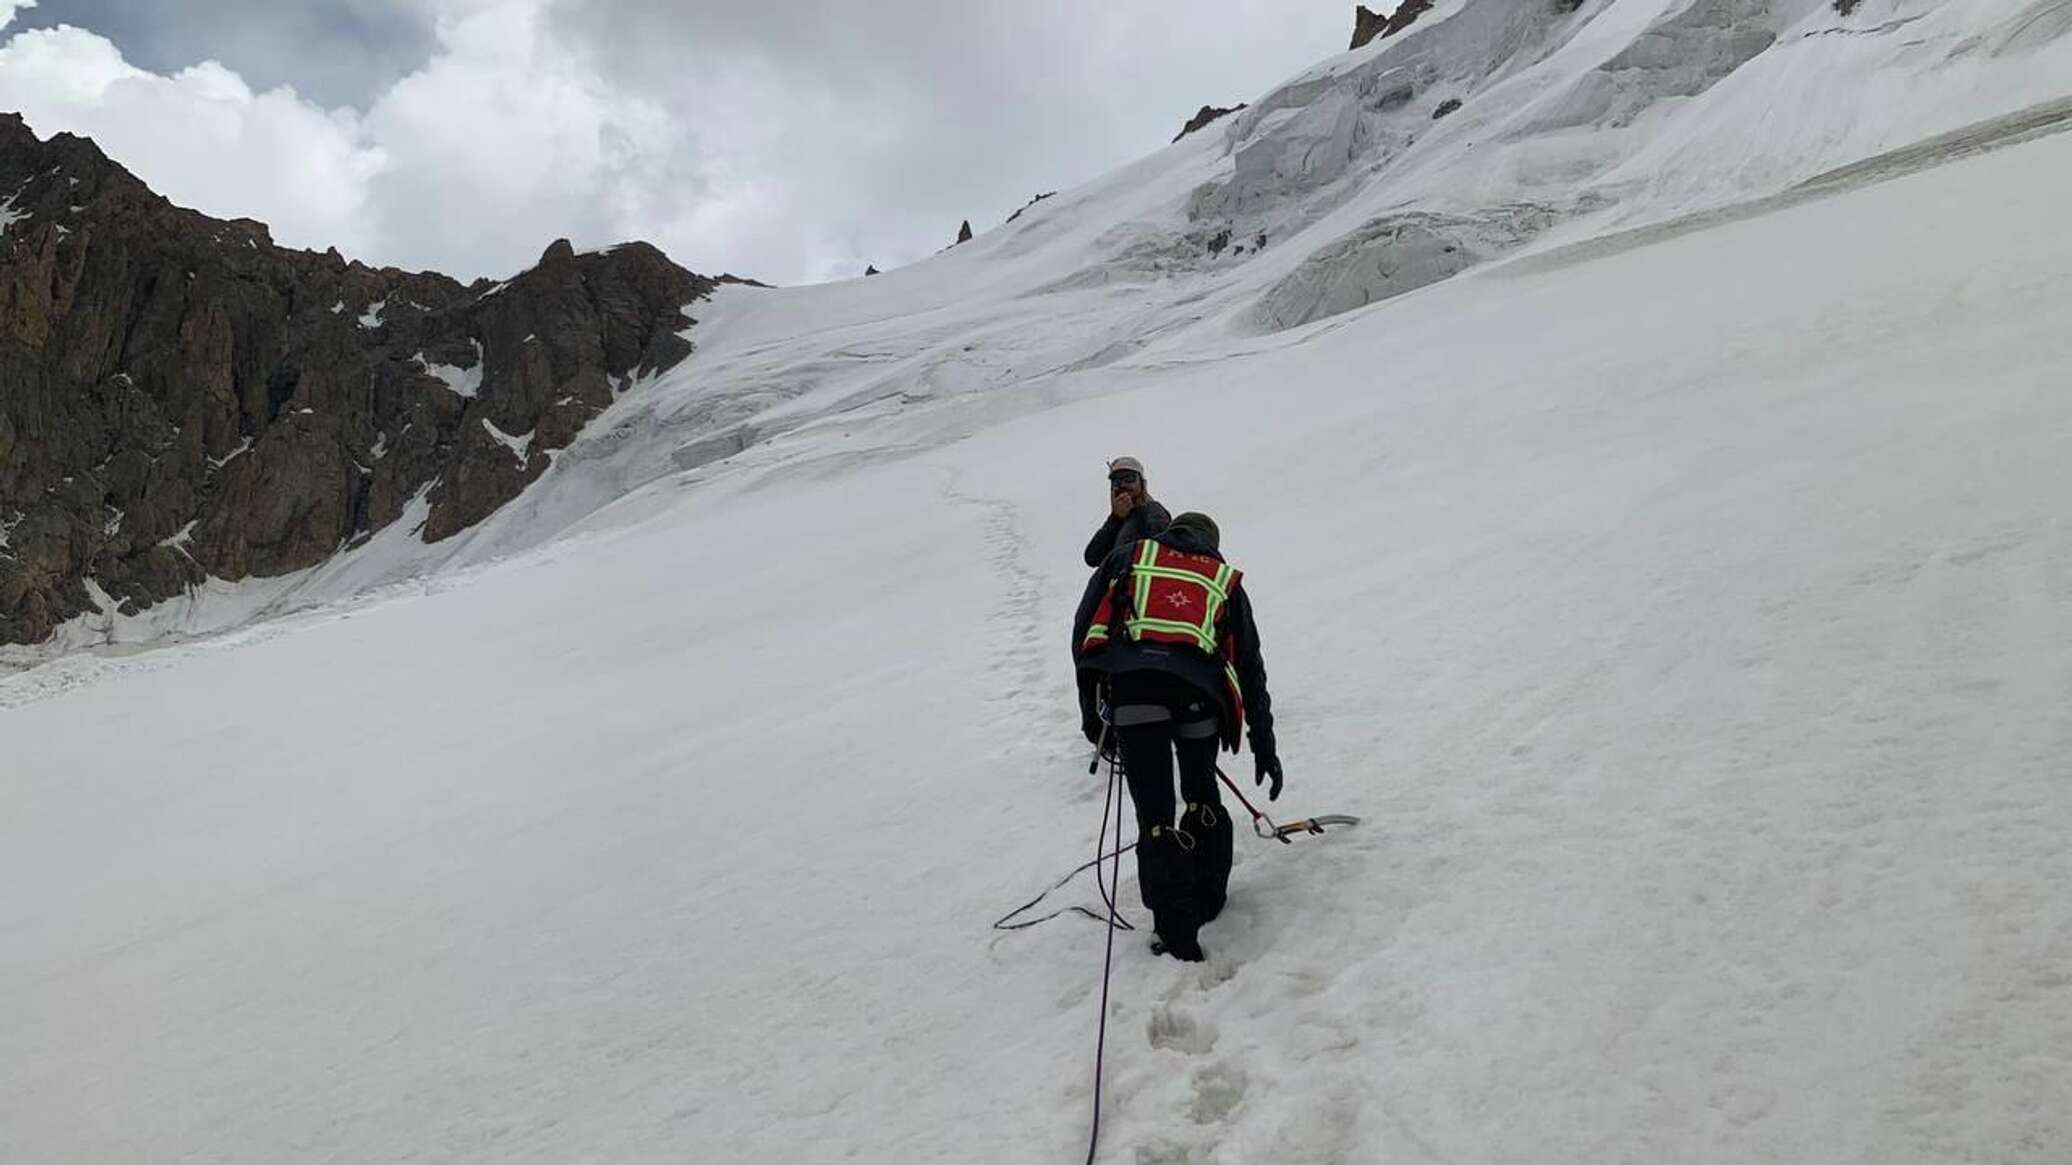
[12,0,2072,661]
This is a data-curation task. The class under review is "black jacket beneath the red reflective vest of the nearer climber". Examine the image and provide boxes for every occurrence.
[1071,529,1276,759]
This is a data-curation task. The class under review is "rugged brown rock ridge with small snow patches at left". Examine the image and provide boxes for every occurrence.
[0,114,713,643]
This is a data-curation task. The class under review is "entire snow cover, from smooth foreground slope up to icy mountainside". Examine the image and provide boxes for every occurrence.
[0,0,2072,1165]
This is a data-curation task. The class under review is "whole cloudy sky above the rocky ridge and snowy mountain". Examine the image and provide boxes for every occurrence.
[0,0,1353,282]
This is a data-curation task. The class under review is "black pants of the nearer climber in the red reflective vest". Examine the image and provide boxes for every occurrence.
[1109,672,1233,939]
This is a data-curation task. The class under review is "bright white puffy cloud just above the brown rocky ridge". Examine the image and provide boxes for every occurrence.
[0,0,696,278]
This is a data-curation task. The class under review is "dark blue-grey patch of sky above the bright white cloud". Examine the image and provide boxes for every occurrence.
[15,0,435,108]
